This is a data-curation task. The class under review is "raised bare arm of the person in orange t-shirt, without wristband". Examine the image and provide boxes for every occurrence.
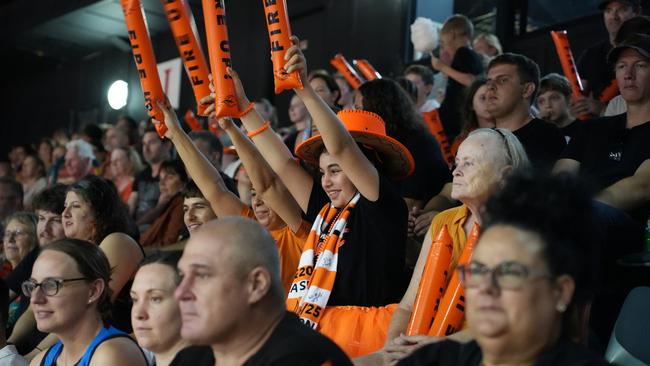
[219,118,302,233]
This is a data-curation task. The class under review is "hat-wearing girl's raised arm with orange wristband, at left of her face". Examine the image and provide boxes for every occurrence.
[201,69,314,212]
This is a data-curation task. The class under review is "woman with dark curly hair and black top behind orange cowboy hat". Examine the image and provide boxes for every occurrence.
[354,79,451,211]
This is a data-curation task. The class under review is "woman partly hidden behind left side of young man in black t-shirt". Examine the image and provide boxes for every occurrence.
[451,76,496,156]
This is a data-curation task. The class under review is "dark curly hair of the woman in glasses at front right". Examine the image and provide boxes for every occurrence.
[483,172,600,338]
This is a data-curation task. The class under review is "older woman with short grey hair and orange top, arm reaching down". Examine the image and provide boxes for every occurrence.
[370,128,528,361]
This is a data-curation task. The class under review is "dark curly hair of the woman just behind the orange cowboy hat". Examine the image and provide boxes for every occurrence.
[359,78,424,142]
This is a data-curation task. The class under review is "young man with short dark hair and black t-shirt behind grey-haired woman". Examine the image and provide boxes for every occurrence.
[487,53,566,171]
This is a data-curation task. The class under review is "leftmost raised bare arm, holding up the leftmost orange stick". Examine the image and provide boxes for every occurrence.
[154,103,244,217]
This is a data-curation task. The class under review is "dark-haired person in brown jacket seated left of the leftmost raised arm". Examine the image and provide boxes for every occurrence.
[140,160,188,247]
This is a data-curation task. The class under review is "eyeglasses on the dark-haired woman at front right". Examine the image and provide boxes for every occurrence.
[456,261,552,290]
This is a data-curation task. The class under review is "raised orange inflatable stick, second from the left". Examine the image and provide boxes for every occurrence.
[161,0,210,116]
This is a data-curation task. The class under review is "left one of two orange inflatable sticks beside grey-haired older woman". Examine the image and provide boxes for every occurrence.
[406,225,453,335]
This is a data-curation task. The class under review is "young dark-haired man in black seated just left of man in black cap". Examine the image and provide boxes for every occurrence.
[537,73,580,142]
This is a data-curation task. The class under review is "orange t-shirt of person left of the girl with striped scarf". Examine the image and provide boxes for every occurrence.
[241,206,311,294]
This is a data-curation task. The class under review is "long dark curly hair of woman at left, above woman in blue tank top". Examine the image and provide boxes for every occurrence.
[68,174,137,244]
